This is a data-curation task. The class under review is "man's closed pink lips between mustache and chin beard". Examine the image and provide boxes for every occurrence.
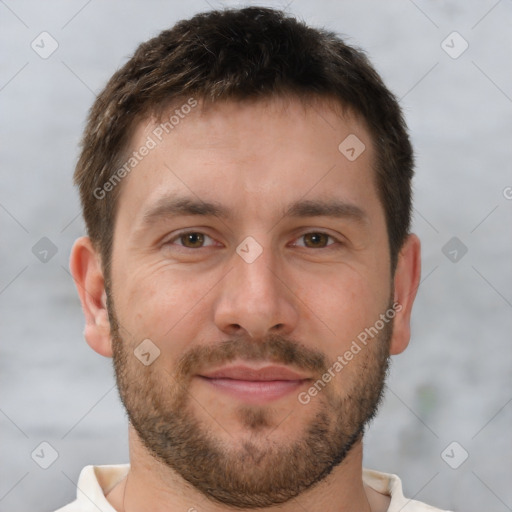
[197,365,312,403]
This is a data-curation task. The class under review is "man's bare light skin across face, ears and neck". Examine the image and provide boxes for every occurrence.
[70,94,420,512]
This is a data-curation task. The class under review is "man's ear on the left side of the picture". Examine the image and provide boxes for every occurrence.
[69,236,112,357]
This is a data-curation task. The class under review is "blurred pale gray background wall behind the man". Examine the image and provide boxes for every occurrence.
[0,0,512,512]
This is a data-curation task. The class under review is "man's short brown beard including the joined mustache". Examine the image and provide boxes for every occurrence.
[107,294,392,509]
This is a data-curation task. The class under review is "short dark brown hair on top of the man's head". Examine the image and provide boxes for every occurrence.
[74,7,413,279]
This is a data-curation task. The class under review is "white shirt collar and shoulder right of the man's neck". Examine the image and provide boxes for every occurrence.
[363,469,450,512]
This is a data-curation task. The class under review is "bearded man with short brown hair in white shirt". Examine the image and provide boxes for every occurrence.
[61,7,448,512]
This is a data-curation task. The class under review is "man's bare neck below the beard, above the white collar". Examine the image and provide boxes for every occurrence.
[106,427,389,512]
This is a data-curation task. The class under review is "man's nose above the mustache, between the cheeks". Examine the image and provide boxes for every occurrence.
[214,242,298,339]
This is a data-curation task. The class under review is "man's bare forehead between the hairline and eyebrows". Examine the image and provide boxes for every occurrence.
[113,98,378,230]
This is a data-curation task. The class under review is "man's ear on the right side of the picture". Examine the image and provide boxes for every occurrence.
[390,234,421,355]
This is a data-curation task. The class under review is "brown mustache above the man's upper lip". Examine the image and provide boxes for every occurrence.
[176,334,327,378]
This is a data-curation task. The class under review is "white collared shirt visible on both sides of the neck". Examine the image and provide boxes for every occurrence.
[56,464,449,512]
